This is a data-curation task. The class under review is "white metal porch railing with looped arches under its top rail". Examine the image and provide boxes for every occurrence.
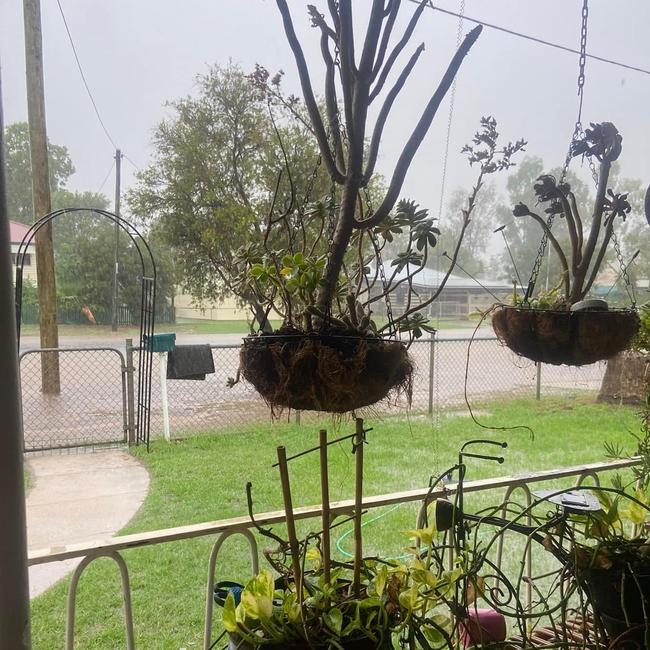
[28,459,639,650]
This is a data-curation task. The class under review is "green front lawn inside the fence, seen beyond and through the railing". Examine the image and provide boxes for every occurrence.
[32,398,637,650]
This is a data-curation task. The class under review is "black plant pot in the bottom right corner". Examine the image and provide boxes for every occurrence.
[583,568,650,649]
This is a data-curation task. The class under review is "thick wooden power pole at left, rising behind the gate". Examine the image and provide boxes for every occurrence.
[23,0,61,395]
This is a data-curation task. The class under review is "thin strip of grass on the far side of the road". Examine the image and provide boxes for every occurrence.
[21,318,476,338]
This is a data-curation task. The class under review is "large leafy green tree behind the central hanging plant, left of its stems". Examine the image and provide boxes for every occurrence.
[127,63,330,330]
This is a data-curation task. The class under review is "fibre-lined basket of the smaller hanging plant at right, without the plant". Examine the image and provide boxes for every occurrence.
[492,305,639,366]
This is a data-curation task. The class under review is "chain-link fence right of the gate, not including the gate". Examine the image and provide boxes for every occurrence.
[136,338,606,437]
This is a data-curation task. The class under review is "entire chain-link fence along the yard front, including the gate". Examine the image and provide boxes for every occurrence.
[20,338,606,450]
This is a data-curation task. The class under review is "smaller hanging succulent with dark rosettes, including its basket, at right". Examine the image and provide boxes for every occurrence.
[492,122,639,366]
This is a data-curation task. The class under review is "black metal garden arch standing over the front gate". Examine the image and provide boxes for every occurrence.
[15,208,156,448]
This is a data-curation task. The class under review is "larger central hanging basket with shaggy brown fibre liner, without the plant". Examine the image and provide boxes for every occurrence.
[240,333,413,413]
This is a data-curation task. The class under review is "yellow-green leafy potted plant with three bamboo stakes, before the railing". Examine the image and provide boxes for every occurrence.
[217,419,476,650]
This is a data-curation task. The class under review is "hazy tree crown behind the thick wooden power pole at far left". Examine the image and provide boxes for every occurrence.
[4,122,75,224]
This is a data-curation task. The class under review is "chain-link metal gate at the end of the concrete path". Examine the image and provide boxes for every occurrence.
[20,347,130,451]
